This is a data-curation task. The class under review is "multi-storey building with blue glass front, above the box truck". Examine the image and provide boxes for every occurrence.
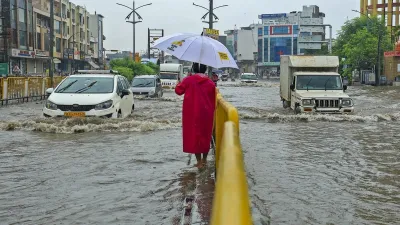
[257,5,329,73]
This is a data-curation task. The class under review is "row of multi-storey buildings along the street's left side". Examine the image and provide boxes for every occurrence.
[0,0,103,74]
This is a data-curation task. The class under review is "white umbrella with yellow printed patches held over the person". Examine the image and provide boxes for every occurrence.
[154,33,238,69]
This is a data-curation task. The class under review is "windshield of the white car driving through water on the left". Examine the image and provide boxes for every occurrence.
[55,77,114,94]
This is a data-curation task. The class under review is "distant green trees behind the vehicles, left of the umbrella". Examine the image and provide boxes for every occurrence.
[110,58,159,80]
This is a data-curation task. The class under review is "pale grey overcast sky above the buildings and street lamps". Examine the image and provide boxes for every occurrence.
[72,0,360,51]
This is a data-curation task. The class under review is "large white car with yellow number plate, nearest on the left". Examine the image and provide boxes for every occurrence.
[43,70,135,118]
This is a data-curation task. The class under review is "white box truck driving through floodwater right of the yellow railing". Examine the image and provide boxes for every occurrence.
[280,55,354,114]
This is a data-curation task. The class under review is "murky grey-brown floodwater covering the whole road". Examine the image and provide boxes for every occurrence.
[0,81,400,225]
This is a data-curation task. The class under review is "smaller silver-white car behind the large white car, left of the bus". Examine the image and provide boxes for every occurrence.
[131,75,163,98]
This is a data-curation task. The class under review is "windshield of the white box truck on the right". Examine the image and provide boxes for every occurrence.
[296,75,343,90]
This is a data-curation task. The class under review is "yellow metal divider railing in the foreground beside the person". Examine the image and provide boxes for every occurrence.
[211,93,253,225]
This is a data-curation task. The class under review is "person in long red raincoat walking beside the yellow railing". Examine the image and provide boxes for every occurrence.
[175,63,216,168]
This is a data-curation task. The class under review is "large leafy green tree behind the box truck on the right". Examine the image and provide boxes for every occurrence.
[333,16,393,77]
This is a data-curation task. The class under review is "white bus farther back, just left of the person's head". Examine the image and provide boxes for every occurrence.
[159,63,184,89]
